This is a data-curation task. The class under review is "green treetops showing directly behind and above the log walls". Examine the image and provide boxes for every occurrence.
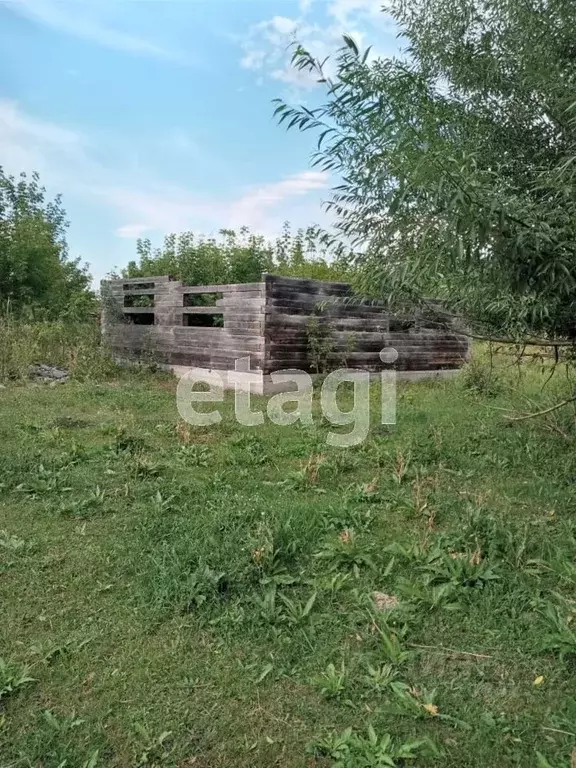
[123,224,350,285]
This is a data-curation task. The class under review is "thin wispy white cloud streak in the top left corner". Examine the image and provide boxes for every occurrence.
[7,0,180,59]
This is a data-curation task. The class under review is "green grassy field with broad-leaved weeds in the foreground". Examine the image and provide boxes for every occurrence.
[0,360,576,768]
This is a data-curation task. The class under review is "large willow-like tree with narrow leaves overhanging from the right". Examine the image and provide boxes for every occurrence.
[276,0,576,338]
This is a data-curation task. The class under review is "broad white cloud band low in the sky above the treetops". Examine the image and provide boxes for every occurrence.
[0,99,328,244]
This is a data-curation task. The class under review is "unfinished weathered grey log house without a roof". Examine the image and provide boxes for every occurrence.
[102,274,470,390]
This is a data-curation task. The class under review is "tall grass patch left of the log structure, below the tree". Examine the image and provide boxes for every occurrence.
[0,316,116,383]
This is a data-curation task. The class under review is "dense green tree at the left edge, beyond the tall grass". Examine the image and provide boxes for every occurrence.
[0,167,95,319]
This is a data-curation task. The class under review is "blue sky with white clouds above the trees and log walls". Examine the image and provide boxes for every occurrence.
[0,0,397,280]
